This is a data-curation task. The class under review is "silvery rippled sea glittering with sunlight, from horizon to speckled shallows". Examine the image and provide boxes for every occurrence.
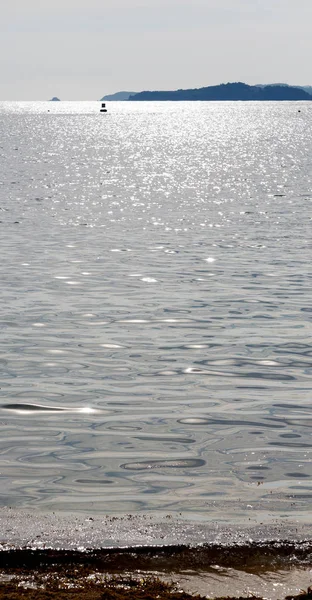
[0,102,312,521]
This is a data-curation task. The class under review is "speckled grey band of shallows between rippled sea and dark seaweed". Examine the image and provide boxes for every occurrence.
[0,507,312,551]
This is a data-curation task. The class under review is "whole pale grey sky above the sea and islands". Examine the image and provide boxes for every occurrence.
[0,0,312,100]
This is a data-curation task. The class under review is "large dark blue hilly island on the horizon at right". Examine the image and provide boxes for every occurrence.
[128,82,312,102]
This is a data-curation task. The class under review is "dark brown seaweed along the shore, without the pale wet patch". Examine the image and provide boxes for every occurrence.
[0,542,312,600]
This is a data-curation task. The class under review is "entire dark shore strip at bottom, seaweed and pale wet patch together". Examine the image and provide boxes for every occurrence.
[0,540,312,600]
